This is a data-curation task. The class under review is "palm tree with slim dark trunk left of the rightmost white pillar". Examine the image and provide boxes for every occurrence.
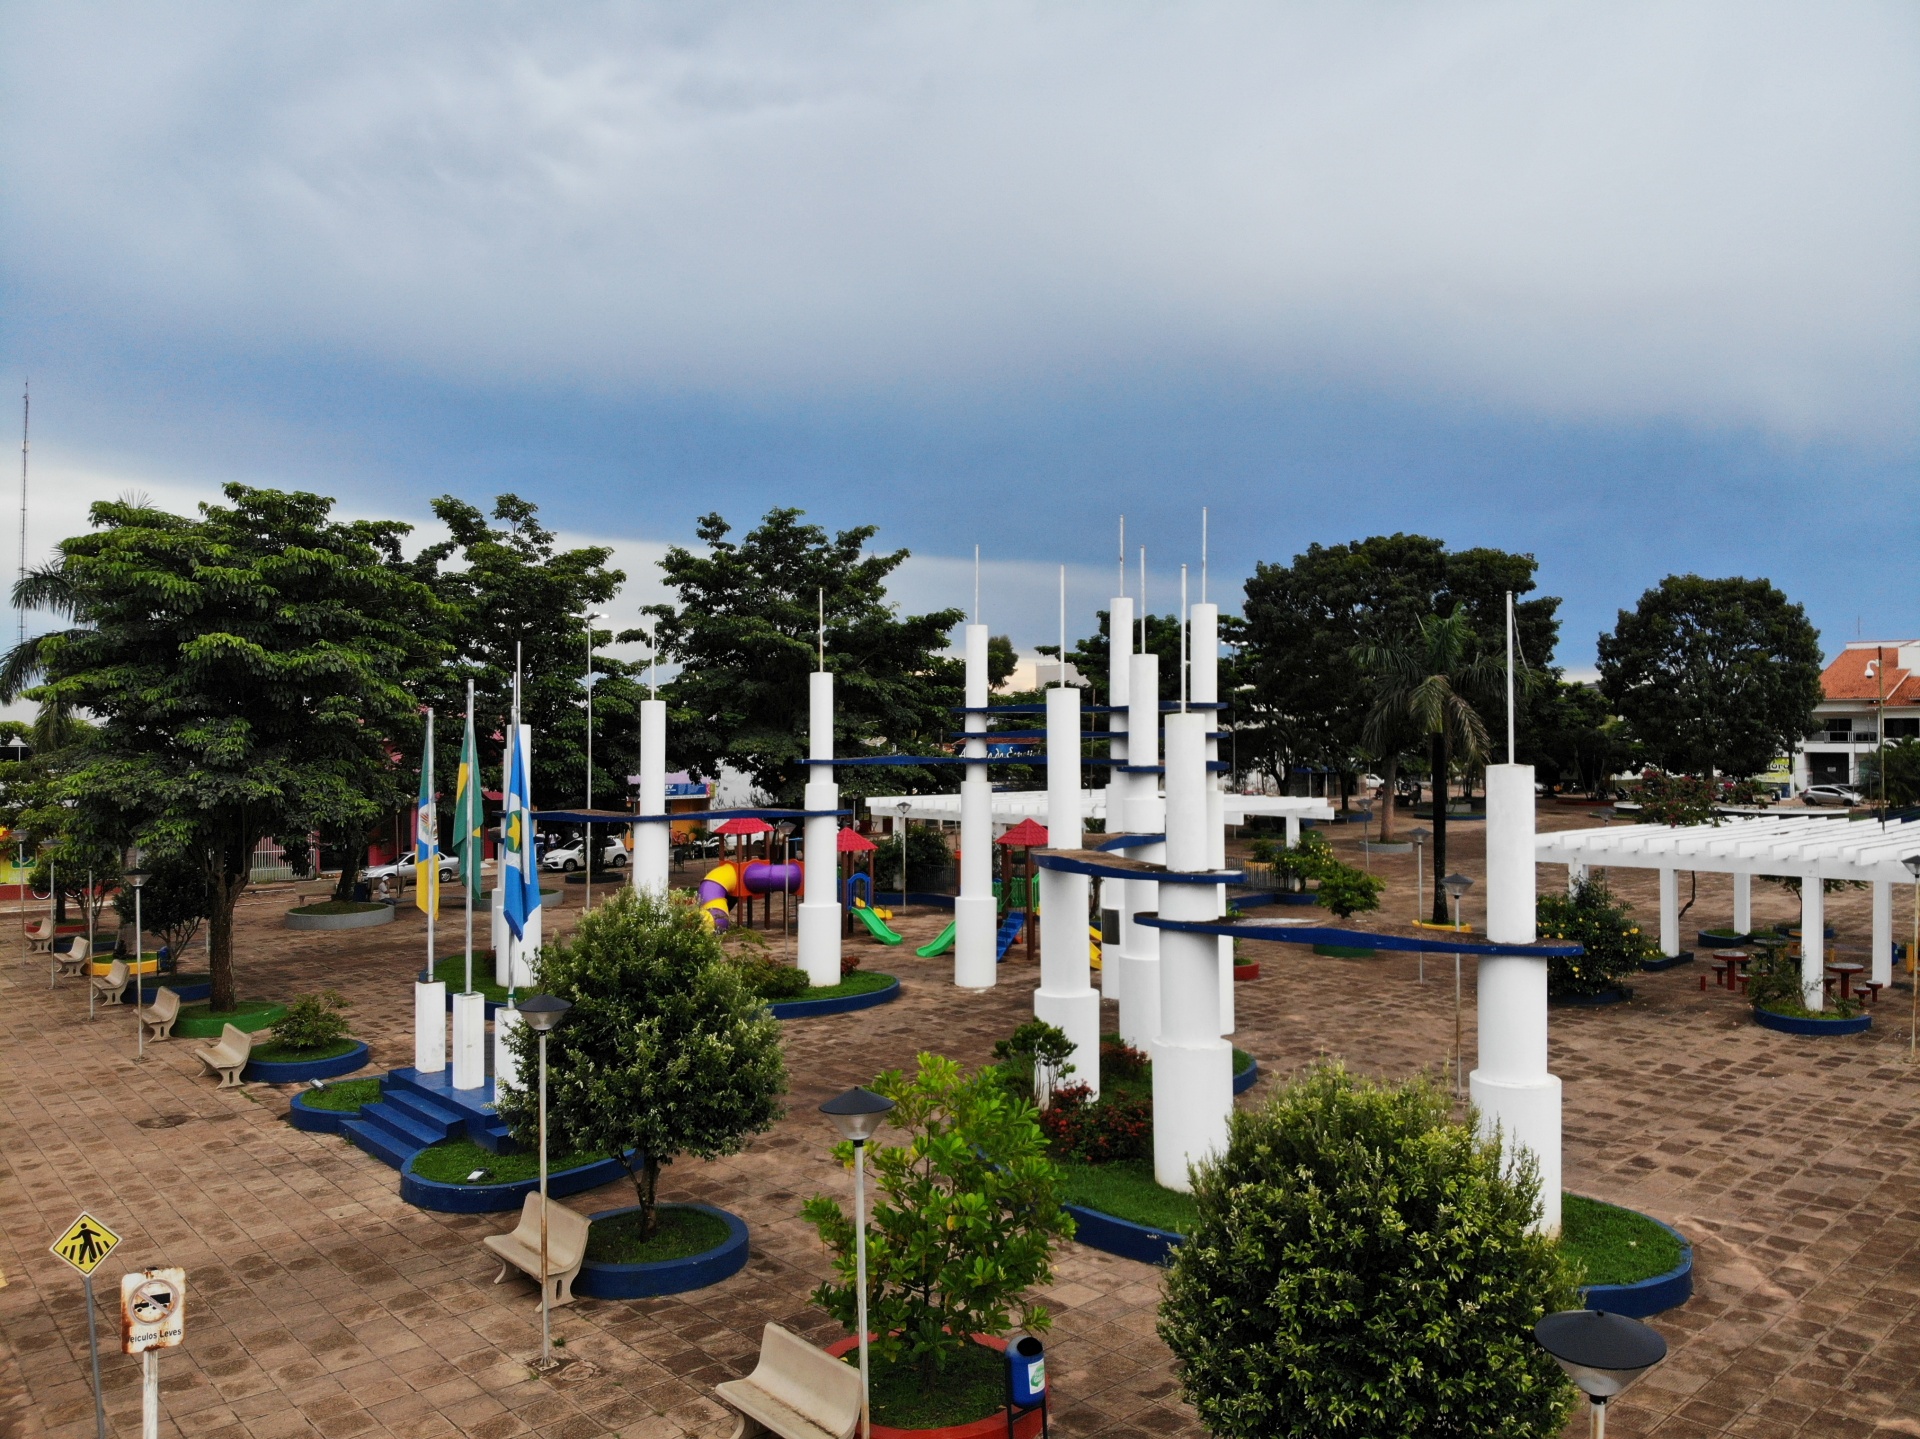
[1352,603,1505,924]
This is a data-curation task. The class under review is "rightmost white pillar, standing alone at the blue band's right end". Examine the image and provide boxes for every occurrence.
[1469,765,1559,1233]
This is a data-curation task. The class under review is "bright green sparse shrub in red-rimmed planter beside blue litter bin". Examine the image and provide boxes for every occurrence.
[801,1055,1073,1393]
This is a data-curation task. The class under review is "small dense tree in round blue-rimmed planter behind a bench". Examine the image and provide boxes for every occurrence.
[495,890,787,1239]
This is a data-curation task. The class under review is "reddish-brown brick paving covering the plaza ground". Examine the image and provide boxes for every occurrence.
[0,813,1920,1439]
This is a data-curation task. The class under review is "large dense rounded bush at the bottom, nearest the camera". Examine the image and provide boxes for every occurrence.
[1160,1066,1576,1439]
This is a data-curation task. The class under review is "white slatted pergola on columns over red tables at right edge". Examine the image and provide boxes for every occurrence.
[1536,815,1920,1009]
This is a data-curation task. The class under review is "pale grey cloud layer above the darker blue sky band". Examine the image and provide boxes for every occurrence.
[0,0,1920,442]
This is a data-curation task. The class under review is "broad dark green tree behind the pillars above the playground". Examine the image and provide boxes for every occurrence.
[647,509,964,803]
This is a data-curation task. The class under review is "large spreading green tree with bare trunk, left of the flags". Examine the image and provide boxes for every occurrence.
[0,484,442,1011]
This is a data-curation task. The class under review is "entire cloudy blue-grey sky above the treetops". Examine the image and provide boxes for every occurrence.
[0,0,1920,674]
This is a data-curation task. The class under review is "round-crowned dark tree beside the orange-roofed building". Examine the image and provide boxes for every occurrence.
[1599,574,1822,778]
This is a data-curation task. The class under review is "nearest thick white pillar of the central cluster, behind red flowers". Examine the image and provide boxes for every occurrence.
[1152,711,1233,1193]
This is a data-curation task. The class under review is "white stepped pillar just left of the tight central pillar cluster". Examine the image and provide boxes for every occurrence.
[1033,684,1100,1097]
